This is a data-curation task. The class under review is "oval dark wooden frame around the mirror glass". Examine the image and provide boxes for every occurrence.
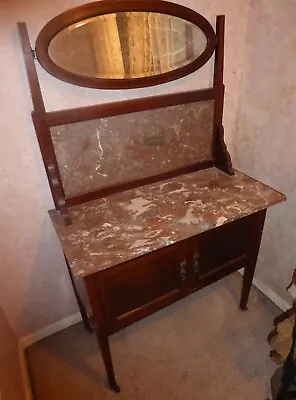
[35,0,217,89]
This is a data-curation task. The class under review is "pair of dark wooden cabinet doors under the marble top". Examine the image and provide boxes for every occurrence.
[98,215,257,333]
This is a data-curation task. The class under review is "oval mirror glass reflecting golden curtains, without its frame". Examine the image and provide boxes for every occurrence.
[49,11,207,79]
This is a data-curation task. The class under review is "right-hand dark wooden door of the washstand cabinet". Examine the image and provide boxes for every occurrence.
[191,217,250,286]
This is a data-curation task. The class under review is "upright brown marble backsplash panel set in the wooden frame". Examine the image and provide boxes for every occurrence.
[51,100,214,197]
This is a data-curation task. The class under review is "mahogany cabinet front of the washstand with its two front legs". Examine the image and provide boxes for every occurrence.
[85,210,266,389]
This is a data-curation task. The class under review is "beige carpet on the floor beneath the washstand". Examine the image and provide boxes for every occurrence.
[27,273,279,400]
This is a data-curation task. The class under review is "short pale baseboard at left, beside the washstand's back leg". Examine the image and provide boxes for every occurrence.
[19,313,82,350]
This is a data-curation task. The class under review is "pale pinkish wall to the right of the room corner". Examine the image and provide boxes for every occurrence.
[234,0,296,302]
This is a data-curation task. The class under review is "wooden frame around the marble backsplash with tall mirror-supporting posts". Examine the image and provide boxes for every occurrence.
[18,15,233,224]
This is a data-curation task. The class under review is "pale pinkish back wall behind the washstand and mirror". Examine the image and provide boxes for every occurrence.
[0,0,249,337]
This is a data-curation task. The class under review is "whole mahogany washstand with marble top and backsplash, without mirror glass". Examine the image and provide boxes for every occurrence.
[18,1,285,391]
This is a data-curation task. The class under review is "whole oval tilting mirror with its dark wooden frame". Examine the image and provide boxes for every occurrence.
[36,0,215,89]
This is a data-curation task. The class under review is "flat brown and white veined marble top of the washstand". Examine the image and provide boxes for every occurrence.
[49,168,285,276]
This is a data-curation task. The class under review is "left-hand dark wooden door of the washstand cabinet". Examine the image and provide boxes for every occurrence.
[101,242,188,330]
